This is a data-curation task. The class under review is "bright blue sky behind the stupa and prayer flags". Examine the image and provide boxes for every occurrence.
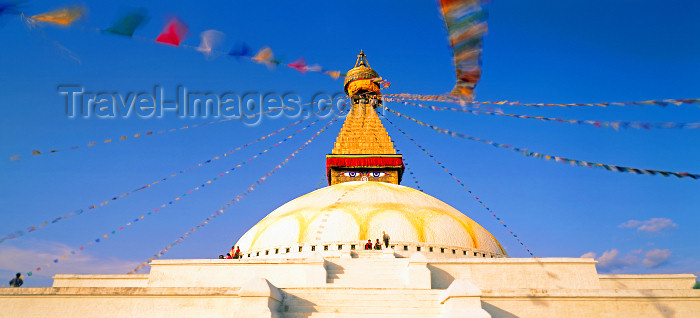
[0,0,700,286]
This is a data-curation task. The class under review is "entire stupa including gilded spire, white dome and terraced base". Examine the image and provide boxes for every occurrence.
[0,53,700,318]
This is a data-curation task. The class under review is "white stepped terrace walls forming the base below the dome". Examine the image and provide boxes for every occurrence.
[0,251,700,318]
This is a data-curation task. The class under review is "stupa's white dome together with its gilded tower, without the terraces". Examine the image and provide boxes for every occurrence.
[236,52,506,258]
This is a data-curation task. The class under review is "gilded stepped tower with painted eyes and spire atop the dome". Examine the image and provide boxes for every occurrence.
[326,51,404,185]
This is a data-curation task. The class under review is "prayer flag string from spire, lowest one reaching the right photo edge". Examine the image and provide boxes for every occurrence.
[383,106,700,180]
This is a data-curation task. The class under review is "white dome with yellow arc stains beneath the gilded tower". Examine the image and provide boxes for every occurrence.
[236,181,506,255]
